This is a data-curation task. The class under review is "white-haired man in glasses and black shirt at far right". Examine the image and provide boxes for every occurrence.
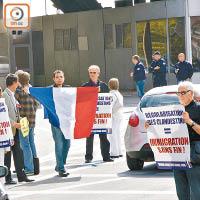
[174,81,200,200]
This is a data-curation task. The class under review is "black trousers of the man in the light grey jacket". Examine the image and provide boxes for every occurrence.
[4,131,26,181]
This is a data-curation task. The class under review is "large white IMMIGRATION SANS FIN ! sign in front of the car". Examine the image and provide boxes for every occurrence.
[142,105,191,169]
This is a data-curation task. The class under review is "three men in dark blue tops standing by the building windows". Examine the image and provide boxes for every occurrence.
[130,51,193,99]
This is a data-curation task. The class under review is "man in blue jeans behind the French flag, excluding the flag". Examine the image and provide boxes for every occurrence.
[51,70,70,177]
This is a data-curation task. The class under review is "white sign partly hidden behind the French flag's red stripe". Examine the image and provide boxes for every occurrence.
[92,93,112,134]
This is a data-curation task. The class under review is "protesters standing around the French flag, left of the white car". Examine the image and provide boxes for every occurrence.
[0,65,123,184]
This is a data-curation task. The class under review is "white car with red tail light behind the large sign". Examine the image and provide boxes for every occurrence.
[124,84,200,170]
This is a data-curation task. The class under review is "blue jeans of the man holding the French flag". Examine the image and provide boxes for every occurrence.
[51,125,70,171]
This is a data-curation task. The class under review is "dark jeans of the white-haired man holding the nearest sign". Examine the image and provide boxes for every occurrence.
[174,166,200,200]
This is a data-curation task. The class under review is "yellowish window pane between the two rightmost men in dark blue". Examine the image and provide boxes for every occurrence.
[168,18,185,72]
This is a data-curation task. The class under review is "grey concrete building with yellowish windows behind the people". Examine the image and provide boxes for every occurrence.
[0,0,200,90]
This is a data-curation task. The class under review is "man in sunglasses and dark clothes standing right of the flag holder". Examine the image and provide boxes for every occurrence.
[82,65,113,163]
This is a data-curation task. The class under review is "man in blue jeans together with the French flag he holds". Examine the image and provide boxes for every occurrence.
[30,70,98,177]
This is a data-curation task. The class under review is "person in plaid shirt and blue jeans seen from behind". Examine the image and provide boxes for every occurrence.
[15,71,39,176]
